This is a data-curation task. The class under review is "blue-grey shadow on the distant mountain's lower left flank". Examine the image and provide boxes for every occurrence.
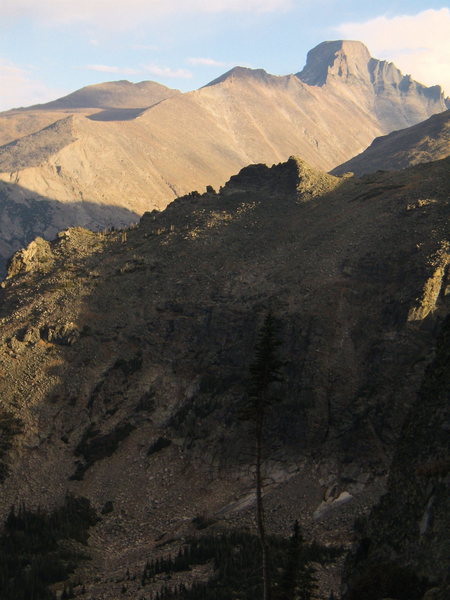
[0,182,139,277]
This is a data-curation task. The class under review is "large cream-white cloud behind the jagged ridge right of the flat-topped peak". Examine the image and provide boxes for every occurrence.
[336,8,450,94]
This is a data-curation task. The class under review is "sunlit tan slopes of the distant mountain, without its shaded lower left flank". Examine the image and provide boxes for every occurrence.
[0,42,445,274]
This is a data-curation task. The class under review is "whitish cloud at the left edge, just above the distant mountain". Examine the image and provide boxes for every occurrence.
[0,58,67,110]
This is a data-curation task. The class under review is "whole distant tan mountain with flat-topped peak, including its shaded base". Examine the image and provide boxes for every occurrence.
[0,41,447,268]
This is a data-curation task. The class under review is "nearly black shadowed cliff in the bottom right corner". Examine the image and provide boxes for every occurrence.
[347,318,450,600]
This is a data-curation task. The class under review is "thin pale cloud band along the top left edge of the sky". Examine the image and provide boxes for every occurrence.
[1,0,294,28]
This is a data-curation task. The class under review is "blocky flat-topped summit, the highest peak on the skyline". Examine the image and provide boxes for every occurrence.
[296,40,371,86]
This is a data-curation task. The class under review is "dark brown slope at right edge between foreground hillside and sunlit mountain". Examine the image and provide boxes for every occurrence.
[332,110,450,175]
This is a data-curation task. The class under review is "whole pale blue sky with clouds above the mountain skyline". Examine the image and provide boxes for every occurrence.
[0,0,450,110]
